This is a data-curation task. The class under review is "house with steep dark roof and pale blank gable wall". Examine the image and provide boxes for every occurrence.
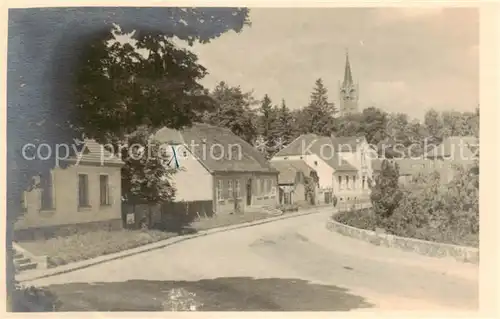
[154,123,278,214]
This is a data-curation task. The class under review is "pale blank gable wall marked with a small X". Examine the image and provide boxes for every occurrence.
[171,146,213,202]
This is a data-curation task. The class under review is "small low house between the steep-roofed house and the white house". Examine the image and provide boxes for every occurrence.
[271,160,318,205]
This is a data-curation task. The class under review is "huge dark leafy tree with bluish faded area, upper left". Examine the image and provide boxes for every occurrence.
[6,8,249,310]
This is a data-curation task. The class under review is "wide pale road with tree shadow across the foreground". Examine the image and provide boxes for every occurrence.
[26,212,479,311]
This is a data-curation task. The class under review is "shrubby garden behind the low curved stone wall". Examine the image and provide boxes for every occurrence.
[333,161,479,247]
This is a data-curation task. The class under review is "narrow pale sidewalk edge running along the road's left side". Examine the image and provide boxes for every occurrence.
[16,206,334,283]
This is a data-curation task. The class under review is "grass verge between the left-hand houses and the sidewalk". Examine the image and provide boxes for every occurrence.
[19,212,282,267]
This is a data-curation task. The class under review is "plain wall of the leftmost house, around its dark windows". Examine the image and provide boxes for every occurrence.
[16,163,122,229]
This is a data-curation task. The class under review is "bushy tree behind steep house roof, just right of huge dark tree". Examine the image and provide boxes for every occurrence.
[204,82,257,144]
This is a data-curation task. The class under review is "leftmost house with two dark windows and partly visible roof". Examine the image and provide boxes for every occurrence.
[15,140,123,229]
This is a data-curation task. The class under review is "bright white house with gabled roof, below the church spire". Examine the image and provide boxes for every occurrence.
[271,134,373,203]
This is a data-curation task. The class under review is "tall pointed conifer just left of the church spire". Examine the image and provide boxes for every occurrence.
[303,78,336,136]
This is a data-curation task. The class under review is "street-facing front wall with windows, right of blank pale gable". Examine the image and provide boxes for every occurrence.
[214,172,279,214]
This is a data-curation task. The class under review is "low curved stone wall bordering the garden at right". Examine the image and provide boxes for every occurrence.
[326,220,479,264]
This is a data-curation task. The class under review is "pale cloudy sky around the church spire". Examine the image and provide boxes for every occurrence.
[178,8,479,119]
